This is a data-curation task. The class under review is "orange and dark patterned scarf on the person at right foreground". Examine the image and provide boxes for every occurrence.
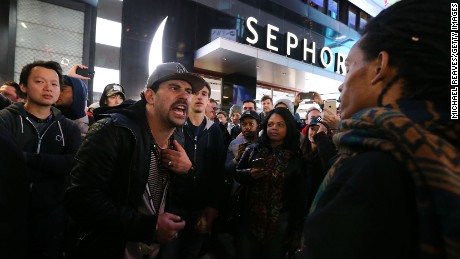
[311,100,460,258]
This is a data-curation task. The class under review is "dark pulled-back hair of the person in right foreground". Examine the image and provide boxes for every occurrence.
[359,0,450,105]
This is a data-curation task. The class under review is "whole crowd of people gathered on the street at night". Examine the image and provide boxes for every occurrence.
[0,0,460,259]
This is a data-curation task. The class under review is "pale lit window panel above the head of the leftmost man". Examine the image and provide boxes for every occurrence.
[14,0,85,81]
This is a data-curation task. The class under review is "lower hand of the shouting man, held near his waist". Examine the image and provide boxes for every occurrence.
[155,212,185,244]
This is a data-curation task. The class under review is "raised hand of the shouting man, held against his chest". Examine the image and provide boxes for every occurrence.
[161,140,192,174]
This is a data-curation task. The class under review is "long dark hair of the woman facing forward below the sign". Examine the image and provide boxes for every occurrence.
[259,107,300,151]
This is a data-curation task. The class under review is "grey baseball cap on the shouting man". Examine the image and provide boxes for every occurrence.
[147,62,206,93]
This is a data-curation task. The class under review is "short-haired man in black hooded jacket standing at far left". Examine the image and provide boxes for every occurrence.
[0,61,81,258]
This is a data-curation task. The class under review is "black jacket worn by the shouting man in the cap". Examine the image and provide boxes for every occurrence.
[65,101,157,258]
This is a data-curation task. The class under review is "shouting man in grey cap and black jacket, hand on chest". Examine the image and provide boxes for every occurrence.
[66,63,205,258]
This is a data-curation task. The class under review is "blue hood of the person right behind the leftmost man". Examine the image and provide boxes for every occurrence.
[58,75,88,120]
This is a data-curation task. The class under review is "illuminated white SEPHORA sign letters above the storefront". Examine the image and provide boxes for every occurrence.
[246,17,346,75]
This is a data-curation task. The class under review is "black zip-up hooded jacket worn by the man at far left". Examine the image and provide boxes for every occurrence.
[0,103,81,210]
